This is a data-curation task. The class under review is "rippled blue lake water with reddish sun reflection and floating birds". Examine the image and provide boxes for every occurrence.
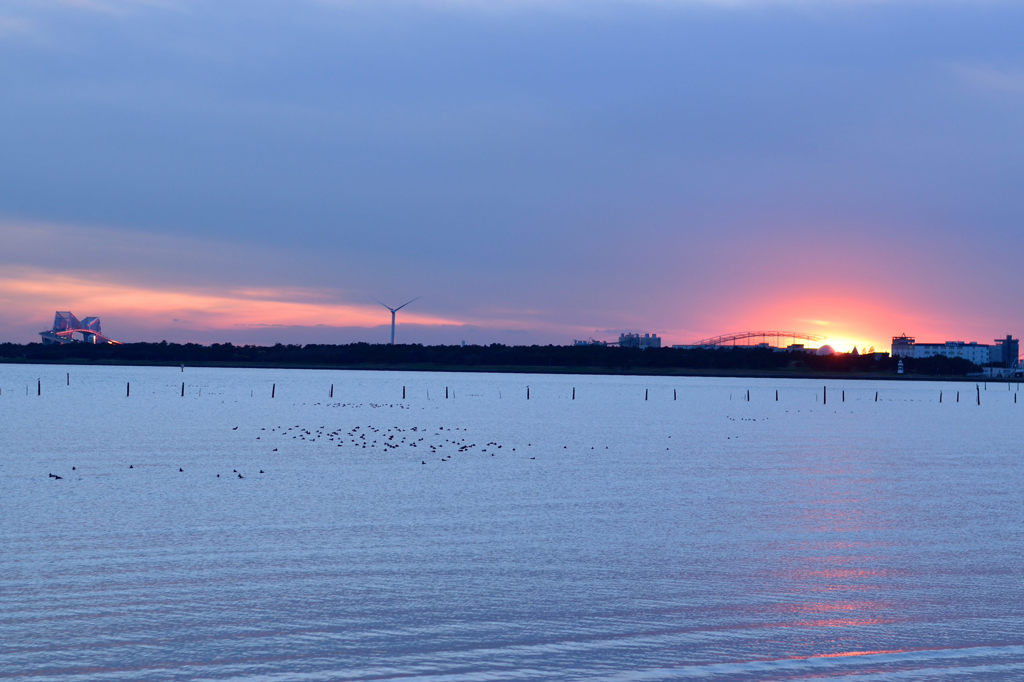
[0,365,1024,681]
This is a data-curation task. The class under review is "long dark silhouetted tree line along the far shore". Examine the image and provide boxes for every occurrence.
[0,341,980,377]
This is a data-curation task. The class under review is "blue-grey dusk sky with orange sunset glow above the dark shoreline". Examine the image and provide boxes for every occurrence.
[0,0,1024,350]
